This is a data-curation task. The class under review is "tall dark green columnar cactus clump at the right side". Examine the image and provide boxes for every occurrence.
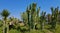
[51,7,59,29]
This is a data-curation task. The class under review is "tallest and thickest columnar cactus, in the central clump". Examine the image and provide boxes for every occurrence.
[31,3,36,29]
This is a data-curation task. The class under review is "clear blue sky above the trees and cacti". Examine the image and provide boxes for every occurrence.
[0,0,60,19]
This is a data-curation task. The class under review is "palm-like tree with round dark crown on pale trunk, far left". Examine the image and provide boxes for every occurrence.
[1,9,10,33]
